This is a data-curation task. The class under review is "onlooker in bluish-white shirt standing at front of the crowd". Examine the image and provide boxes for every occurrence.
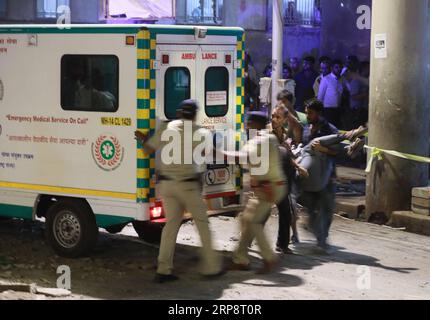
[318,60,343,127]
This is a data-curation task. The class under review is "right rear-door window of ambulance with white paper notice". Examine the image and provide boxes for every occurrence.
[205,67,229,117]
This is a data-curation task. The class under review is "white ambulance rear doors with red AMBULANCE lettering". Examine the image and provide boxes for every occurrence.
[156,44,240,204]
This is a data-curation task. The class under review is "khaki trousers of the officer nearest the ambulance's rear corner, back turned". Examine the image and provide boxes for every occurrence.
[157,181,222,275]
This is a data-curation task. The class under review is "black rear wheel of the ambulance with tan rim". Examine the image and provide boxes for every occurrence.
[46,199,98,258]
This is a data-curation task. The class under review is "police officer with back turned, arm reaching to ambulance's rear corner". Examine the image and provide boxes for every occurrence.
[135,100,223,283]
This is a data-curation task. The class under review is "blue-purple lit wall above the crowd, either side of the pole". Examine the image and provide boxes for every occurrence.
[247,0,372,72]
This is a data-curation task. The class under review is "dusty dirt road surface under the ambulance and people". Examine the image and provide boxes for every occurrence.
[0,210,430,300]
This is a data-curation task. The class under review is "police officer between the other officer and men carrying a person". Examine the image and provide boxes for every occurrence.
[226,112,287,274]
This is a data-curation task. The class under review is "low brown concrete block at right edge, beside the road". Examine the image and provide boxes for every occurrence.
[389,211,430,236]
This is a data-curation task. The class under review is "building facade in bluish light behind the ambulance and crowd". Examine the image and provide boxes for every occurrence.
[0,0,372,73]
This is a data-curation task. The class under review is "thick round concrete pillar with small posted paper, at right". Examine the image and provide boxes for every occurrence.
[366,0,430,218]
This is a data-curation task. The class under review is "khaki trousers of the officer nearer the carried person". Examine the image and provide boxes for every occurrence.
[233,184,287,265]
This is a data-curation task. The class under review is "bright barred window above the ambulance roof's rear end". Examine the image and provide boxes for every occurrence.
[179,0,224,24]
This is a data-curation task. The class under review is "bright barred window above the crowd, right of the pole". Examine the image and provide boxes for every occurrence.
[283,0,321,26]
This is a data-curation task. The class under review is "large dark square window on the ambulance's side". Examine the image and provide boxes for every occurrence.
[61,55,119,112]
